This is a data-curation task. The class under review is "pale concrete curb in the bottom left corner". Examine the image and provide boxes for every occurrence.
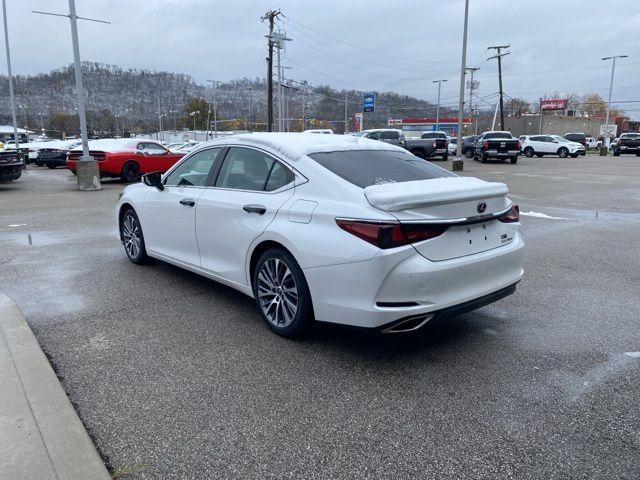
[0,294,111,480]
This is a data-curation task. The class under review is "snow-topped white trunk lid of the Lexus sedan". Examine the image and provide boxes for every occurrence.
[364,177,513,261]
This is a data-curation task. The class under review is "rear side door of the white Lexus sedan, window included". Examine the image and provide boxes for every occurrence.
[196,146,295,285]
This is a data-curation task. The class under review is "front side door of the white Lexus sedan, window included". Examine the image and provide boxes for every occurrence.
[141,147,222,267]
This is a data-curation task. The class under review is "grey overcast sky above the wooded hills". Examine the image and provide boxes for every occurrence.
[5,0,640,117]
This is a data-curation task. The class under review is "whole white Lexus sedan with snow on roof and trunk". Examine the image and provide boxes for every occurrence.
[116,133,524,336]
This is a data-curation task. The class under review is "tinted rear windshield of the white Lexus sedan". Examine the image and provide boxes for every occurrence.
[309,150,455,188]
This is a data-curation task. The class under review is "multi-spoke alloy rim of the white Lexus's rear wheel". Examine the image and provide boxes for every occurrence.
[257,257,298,328]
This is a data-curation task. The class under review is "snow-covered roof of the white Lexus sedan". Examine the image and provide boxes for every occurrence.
[194,132,406,160]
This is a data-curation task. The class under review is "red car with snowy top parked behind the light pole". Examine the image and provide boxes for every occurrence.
[67,138,184,182]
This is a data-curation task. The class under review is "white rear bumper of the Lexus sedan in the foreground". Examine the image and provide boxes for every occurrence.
[304,232,524,329]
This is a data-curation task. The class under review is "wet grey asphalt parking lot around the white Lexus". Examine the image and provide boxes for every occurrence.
[0,155,640,479]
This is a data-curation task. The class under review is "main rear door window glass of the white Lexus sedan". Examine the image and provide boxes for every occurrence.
[215,147,275,191]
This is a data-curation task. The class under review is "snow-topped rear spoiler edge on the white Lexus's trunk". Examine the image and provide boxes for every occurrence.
[364,177,509,212]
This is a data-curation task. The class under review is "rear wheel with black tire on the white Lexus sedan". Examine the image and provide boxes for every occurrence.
[251,248,313,338]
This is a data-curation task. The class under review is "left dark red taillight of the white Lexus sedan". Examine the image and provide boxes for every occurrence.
[336,219,447,249]
